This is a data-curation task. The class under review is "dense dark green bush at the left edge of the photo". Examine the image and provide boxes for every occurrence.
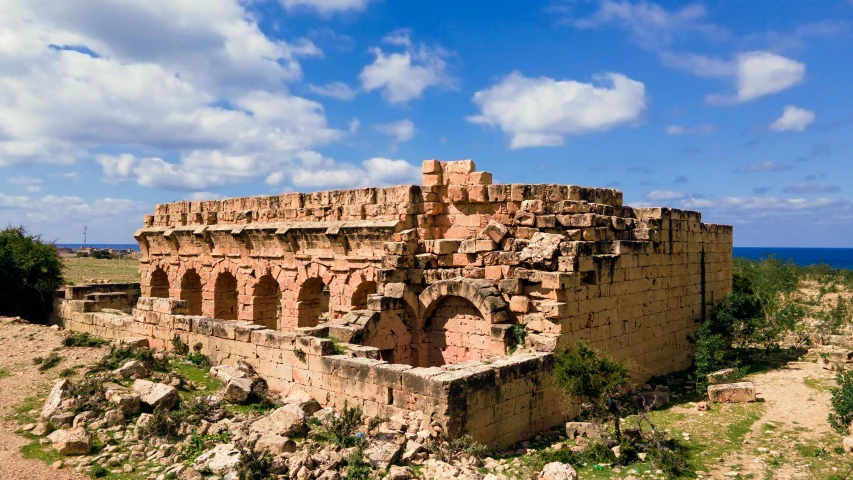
[0,226,63,322]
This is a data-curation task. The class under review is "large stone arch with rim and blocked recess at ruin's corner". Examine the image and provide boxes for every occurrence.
[417,279,509,367]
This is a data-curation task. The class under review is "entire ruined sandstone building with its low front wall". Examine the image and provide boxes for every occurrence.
[57,160,732,446]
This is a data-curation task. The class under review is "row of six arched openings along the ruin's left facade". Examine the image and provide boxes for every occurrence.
[148,267,377,330]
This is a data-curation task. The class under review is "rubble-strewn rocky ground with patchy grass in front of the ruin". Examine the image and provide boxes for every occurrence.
[0,319,853,480]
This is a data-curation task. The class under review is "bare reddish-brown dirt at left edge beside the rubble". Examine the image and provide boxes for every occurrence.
[0,318,105,480]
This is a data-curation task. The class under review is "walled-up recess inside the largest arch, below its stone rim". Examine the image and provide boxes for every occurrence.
[421,296,492,367]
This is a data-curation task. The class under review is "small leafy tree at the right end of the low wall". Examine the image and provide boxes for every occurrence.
[555,342,632,441]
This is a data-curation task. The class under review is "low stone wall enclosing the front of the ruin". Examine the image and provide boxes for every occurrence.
[58,297,565,447]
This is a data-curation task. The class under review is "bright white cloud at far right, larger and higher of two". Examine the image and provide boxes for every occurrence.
[706,52,806,105]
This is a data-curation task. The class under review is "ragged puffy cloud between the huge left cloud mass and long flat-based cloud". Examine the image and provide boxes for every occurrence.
[358,31,455,103]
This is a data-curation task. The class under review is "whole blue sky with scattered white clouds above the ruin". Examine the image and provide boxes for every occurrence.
[0,0,853,247]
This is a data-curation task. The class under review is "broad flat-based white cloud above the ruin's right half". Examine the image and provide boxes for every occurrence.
[468,72,646,149]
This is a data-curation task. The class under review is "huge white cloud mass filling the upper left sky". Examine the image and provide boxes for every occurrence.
[0,0,344,190]
